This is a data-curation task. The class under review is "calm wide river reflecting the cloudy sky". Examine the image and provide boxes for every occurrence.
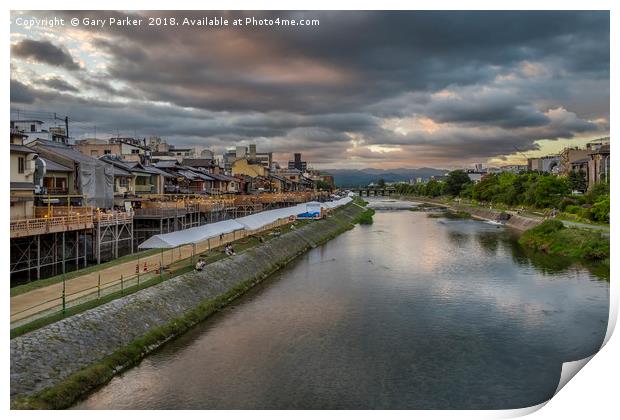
[75,202,609,409]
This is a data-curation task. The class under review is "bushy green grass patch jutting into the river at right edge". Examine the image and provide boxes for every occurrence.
[519,220,609,267]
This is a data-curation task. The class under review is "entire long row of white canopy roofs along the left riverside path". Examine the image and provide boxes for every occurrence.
[138,197,352,249]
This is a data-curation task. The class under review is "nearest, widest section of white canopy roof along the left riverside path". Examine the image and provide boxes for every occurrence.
[138,220,244,249]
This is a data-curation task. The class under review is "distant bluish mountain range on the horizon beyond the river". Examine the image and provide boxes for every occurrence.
[325,168,448,187]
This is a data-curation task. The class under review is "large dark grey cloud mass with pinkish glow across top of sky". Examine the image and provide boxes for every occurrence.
[74,12,609,113]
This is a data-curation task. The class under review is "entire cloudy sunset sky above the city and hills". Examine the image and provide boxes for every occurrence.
[11,11,609,168]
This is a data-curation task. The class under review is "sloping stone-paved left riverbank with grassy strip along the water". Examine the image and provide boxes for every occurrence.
[11,204,365,408]
